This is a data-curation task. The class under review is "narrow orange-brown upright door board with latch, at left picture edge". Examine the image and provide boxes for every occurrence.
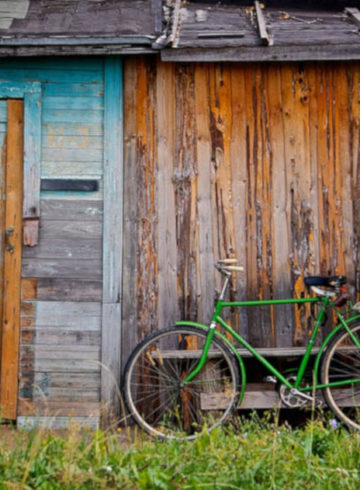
[0,99,24,419]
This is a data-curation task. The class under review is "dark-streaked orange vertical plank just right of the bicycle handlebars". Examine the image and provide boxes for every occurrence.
[245,65,275,347]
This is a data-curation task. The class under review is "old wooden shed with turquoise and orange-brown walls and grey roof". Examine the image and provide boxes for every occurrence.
[0,0,360,426]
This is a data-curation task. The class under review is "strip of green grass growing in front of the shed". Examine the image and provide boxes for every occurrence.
[0,416,360,490]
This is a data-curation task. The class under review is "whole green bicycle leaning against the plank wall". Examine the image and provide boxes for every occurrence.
[123,259,360,440]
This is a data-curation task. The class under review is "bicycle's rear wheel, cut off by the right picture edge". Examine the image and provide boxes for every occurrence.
[321,321,360,430]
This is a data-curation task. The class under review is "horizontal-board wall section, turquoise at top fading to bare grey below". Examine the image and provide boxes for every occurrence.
[0,58,104,421]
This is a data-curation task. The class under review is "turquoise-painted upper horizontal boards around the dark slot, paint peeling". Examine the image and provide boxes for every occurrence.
[0,58,104,200]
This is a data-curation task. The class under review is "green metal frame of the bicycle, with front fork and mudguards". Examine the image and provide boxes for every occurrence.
[176,294,360,399]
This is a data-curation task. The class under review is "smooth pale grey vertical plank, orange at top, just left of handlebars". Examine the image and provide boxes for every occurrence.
[195,64,214,322]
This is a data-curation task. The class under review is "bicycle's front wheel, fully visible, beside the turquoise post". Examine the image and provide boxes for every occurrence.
[124,326,240,439]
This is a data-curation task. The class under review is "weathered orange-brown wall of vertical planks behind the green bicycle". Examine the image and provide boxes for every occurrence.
[123,58,360,359]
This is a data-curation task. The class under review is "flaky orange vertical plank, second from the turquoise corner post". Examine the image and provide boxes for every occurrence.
[135,58,158,339]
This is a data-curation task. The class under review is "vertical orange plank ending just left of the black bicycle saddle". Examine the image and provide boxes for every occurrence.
[281,64,314,345]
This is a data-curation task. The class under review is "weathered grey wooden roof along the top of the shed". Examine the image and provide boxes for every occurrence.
[0,0,360,61]
